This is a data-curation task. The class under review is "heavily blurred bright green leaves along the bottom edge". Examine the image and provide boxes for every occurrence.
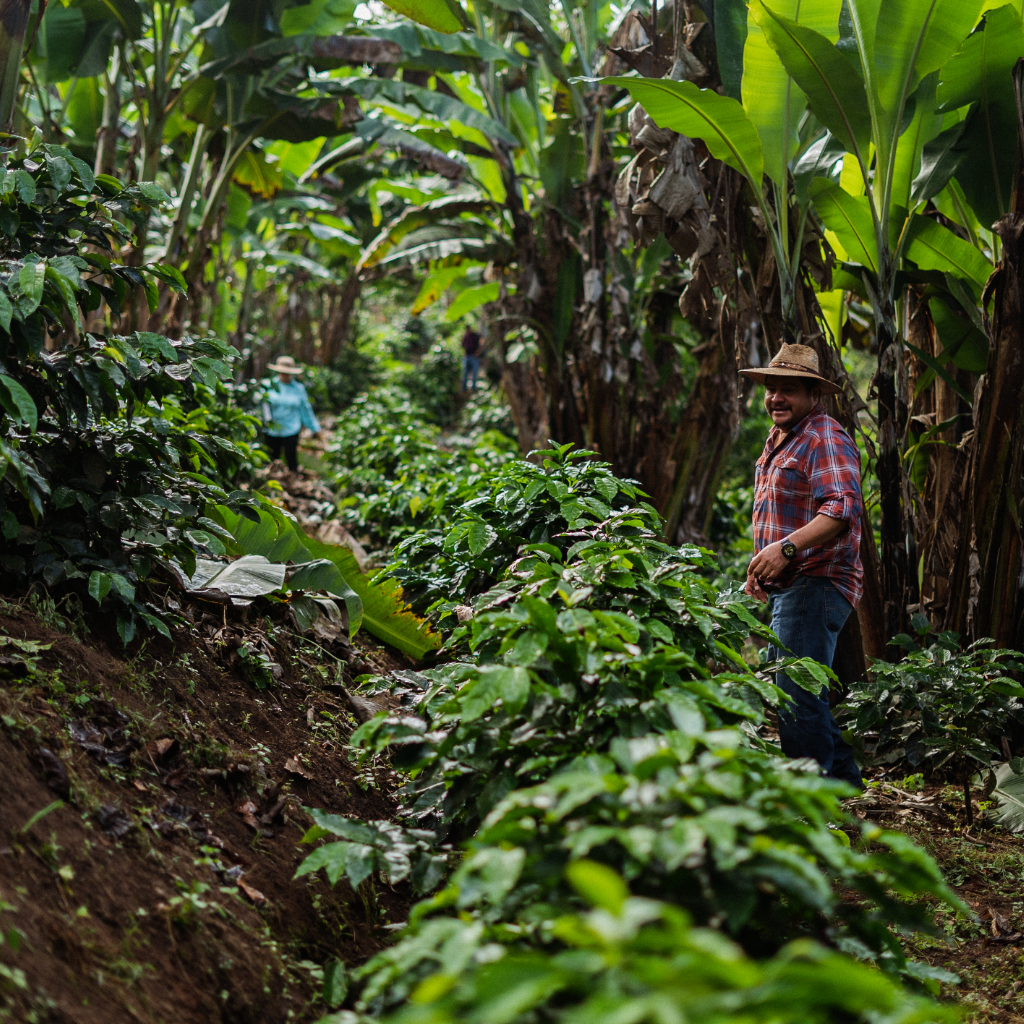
[376,860,958,1024]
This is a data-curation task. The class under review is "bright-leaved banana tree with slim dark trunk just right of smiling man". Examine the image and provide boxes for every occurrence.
[751,0,1003,635]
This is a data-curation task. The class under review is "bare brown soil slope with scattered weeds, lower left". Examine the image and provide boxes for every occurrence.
[0,604,407,1024]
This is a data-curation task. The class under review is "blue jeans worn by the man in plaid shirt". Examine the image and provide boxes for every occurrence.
[768,575,864,790]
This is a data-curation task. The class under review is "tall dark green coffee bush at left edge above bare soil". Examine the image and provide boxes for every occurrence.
[0,146,256,643]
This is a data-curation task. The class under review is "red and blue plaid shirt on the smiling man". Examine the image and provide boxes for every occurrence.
[754,406,864,606]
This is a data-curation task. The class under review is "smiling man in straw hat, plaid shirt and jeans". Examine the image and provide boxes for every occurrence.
[739,345,864,788]
